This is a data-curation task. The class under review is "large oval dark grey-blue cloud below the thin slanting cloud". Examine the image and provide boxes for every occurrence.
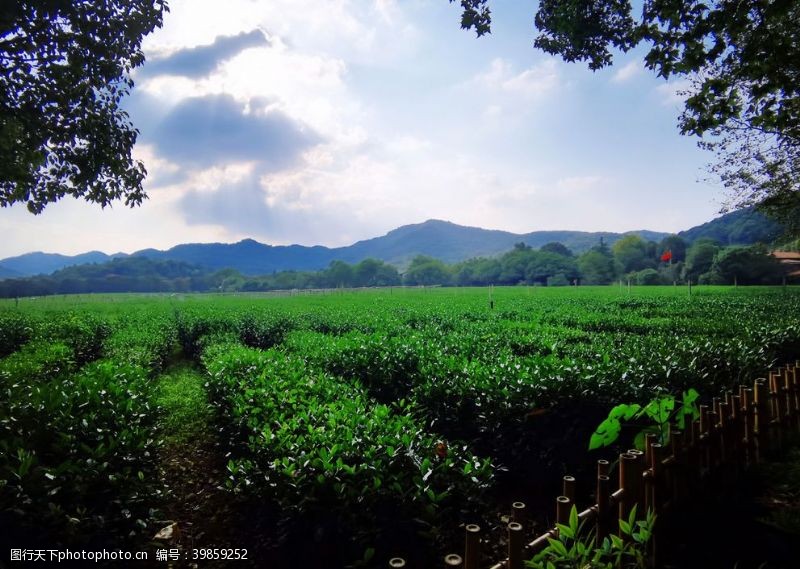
[153,95,321,171]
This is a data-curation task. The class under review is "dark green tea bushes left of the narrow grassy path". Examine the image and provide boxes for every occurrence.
[0,332,161,545]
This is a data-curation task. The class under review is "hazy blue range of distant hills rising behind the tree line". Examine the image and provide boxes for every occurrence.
[0,210,780,278]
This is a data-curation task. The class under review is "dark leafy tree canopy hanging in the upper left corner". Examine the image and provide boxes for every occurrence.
[0,0,168,213]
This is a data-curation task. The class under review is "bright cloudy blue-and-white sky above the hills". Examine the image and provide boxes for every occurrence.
[0,0,724,258]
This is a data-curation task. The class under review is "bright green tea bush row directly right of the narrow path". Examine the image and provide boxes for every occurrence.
[198,343,491,532]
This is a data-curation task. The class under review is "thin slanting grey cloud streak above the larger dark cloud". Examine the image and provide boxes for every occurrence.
[138,30,270,78]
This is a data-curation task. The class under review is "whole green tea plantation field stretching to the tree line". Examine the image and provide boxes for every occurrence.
[0,287,800,567]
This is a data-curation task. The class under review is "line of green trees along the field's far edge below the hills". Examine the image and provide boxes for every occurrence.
[0,235,784,298]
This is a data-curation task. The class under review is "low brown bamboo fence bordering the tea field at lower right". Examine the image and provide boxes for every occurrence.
[389,361,800,569]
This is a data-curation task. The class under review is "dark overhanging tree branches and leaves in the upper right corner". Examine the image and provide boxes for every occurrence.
[450,0,800,232]
